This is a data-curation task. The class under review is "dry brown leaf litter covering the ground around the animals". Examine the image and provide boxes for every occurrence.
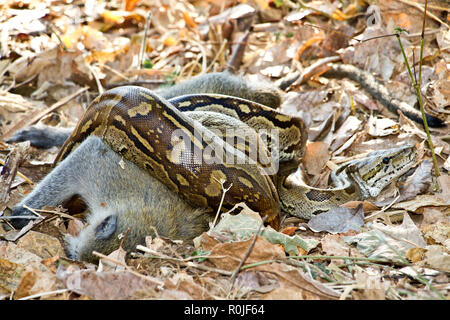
[0,0,450,299]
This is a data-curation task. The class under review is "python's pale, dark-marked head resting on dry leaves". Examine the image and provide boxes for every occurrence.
[346,145,417,199]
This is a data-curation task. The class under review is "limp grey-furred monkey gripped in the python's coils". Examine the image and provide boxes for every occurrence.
[7,73,281,261]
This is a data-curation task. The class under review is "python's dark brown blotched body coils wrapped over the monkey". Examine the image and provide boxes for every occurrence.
[55,86,305,228]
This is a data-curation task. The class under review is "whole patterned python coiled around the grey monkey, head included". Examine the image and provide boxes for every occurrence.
[55,86,416,225]
